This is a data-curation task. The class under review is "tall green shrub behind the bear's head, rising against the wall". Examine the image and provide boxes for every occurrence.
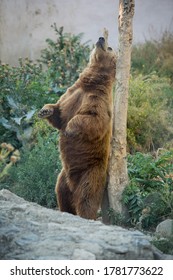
[40,24,91,95]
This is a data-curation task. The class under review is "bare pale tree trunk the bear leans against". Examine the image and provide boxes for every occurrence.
[103,0,134,221]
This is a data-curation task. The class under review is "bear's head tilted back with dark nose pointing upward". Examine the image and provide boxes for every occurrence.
[89,37,116,69]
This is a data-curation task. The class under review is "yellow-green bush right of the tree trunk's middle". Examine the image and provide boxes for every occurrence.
[127,73,173,152]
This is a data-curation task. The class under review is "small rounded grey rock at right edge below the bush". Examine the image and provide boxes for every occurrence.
[156,219,173,237]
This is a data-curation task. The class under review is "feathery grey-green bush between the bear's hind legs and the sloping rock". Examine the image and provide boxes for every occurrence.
[1,132,61,207]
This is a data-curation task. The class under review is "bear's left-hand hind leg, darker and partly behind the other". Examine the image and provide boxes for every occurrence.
[55,170,76,215]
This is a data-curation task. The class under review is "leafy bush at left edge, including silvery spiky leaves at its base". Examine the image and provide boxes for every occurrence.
[0,59,54,148]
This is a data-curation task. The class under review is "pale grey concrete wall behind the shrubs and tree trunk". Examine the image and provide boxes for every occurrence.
[0,0,173,65]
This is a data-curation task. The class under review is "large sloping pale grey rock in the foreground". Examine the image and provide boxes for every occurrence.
[0,190,170,260]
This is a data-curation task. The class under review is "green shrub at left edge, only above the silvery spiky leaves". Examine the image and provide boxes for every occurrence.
[0,58,48,110]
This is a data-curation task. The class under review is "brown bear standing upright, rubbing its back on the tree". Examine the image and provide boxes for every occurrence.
[39,37,116,219]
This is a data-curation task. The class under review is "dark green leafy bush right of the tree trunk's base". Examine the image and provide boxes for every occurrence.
[123,150,173,229]
